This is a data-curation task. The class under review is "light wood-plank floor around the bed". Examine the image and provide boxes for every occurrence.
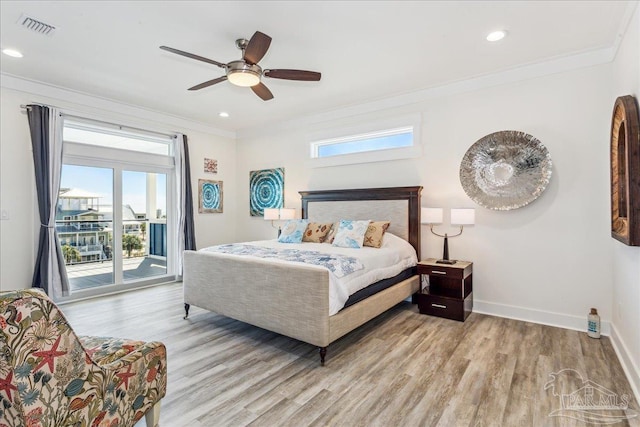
[61,283,640,427]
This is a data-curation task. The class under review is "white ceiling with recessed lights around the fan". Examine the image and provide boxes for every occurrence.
[0,0,637,131]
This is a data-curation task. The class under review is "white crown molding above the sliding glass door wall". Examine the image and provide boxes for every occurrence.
[0,73,236,139]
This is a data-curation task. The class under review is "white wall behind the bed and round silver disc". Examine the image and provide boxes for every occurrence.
[237,64,612,330]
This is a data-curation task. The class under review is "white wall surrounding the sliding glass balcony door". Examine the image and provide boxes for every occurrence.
[0,83,236,290]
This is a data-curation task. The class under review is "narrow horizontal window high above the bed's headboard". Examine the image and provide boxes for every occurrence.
[308,115,422,167]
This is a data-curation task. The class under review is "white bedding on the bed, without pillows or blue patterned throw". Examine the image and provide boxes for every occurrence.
[201,232,418,316]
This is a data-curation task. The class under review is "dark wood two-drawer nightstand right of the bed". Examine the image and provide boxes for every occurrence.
[416,258,473,322]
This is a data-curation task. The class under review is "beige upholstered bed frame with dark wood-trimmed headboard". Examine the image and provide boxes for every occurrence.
[183,186,422,365]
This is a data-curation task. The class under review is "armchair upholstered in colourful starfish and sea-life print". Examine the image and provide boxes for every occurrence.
[0,289,167,427]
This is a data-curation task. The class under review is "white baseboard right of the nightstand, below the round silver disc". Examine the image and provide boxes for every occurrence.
[473,300,611,336]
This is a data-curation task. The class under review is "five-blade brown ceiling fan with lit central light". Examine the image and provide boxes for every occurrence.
[160,31,321,101]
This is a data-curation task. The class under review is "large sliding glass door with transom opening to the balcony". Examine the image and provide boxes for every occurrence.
[56,118,177,298]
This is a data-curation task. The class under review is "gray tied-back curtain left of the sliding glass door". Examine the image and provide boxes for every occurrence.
[27,105,69,298]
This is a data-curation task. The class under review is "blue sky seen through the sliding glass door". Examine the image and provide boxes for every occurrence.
[60,165,167,214]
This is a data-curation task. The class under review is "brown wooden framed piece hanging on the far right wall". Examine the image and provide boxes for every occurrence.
[611,95,640,246]
